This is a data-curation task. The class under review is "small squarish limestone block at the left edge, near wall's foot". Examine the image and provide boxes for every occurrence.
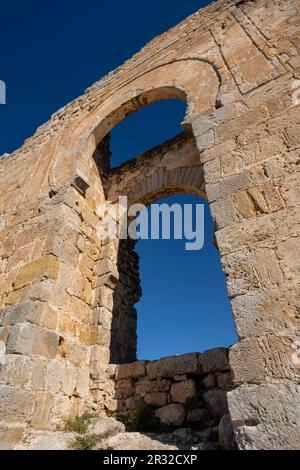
[0,385,35,422]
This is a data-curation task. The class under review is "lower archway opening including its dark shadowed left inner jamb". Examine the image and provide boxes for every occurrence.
[111,194,237,363]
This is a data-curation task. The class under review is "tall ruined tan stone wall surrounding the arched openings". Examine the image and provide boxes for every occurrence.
[0,0,300,448]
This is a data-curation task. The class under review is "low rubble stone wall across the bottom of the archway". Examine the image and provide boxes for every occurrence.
[111,348,235,448]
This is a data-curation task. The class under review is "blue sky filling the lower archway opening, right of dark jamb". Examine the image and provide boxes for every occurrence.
[136,194,237,360]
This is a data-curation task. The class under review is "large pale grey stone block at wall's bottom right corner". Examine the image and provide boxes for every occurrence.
[228,383,300,450]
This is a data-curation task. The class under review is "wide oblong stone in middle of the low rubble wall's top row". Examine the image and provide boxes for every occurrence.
[147,354,199,379]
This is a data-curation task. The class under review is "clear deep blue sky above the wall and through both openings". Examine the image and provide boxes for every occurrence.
[0,0,236,359]
